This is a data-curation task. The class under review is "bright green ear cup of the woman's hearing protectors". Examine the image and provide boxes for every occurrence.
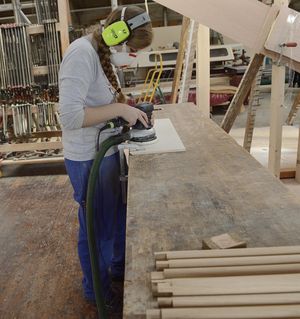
[102,21,130,47]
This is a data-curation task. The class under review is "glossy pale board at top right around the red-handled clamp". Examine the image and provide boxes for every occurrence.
[265,7,300,62]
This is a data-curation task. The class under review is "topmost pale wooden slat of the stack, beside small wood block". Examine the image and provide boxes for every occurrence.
[154,246,300,260]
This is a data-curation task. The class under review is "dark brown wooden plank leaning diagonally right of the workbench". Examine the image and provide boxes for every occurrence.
[221,54,264,133]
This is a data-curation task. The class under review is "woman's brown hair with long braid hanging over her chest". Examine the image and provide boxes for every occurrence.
[93,6,153,103]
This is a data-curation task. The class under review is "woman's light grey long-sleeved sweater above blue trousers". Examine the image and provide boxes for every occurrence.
[59,37,119,161]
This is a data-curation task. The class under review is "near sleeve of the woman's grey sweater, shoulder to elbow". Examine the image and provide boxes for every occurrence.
[59,46,95,130]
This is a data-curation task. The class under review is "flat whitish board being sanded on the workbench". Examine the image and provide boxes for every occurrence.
[130,119,185,155]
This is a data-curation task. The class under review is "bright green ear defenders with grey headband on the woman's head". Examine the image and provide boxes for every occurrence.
[102,7,151,47]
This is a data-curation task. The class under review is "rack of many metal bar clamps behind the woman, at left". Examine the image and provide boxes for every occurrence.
[0,0,69,175]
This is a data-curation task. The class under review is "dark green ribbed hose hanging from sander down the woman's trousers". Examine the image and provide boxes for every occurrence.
[86,134,129,319]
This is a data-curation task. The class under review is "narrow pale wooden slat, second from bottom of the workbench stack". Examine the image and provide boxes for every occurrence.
[157,293,300,310]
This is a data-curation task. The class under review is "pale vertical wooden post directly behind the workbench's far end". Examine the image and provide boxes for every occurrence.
[196,24,210,118]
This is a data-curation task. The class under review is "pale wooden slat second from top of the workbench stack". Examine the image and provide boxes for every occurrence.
[156,255,300,270]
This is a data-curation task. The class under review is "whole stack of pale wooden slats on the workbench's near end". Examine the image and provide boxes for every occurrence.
[147,246,300,319]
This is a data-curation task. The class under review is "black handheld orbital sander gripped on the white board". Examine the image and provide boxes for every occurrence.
[130,102,157,143]
